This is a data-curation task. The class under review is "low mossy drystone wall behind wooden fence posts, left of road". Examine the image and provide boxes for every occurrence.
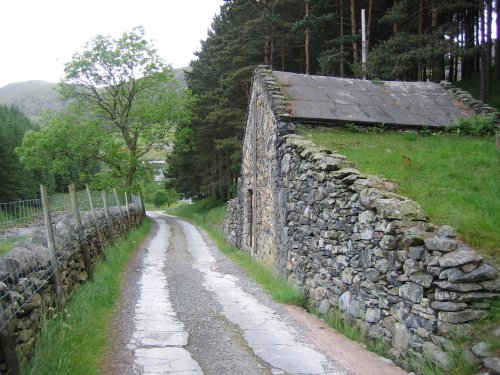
[0,205,144,374]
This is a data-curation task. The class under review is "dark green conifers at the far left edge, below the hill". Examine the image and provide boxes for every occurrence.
[0,105,37,202]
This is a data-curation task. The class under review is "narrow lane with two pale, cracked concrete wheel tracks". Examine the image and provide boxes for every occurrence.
[103,212,404,375]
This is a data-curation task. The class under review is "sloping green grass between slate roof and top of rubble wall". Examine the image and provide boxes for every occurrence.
[299,127,500,260]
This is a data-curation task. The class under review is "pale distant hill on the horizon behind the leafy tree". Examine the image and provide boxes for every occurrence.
[0,67,191,121]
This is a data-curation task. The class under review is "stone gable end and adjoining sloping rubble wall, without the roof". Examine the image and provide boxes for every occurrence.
[224,67,500,368]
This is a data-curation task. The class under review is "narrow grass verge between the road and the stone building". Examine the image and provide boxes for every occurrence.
[167,198,306,307]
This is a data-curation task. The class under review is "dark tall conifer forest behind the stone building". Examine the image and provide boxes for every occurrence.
[169,0,500,199]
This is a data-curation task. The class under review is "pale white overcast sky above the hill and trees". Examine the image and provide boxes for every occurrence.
[0,0,223,87]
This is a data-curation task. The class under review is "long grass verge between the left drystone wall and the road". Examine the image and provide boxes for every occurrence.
[22,218,152,375]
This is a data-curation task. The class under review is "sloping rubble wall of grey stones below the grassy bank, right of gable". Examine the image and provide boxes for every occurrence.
[281,135,500,367]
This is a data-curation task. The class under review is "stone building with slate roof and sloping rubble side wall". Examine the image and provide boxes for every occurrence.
[224,67,499,374]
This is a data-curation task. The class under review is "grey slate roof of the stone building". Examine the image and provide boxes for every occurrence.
[272,71,469,127]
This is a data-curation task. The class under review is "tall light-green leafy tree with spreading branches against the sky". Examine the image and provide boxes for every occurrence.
[58,27,190,187]
